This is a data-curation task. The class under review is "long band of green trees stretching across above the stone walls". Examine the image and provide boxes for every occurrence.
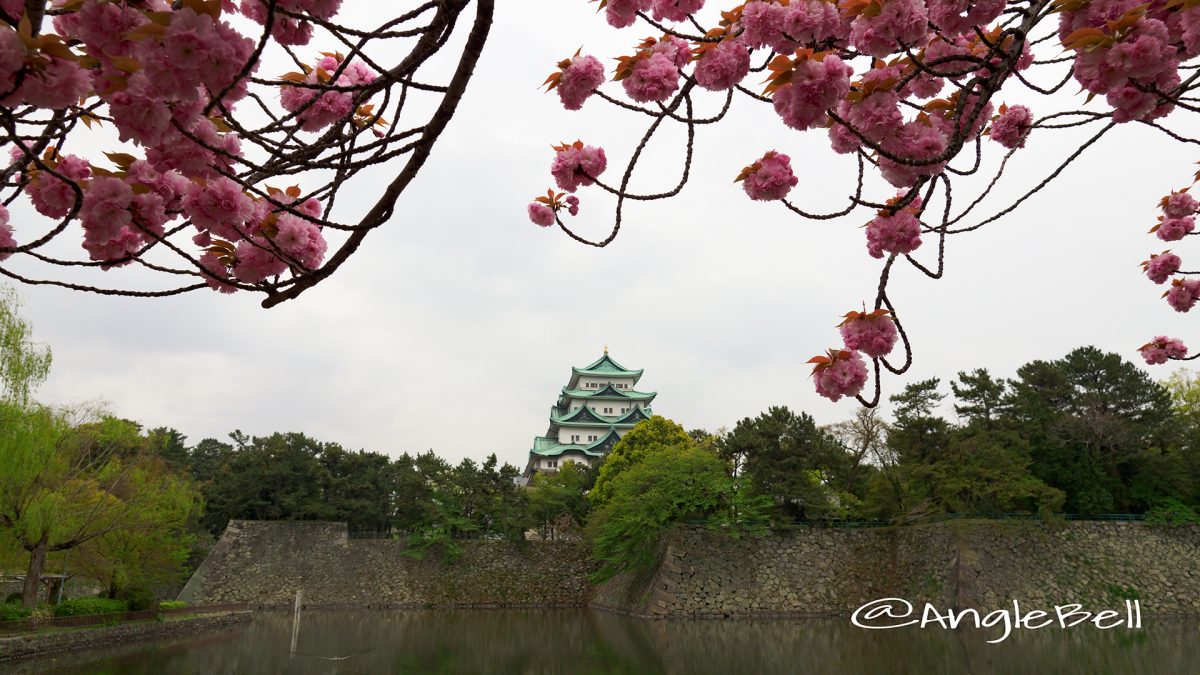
[0,338,1200,604]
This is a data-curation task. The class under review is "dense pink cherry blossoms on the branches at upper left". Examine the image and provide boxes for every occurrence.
[0,0,379,292]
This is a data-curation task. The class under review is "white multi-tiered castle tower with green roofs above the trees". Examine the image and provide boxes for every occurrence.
[524,347,658,478]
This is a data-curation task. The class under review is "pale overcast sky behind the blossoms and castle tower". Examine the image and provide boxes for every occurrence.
[10,0,1200,466]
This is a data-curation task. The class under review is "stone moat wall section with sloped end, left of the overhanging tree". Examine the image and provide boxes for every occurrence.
[179,520,592,607]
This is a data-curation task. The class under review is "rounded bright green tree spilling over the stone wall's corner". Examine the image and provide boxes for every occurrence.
[588,444,767,581]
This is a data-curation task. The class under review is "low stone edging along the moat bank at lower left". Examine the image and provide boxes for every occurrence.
[0,611,251,663]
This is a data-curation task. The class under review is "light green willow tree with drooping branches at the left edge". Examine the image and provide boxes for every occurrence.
[0,288,197,607]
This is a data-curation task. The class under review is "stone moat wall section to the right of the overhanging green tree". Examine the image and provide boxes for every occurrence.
[592,521,1200,616]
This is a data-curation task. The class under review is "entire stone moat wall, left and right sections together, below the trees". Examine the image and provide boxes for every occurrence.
[180,520,1200,617]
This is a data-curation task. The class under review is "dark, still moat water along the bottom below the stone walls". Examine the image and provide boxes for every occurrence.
[11,609,1200,675]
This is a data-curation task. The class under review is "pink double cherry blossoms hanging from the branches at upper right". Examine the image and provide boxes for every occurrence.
[529,0,1200,400]
